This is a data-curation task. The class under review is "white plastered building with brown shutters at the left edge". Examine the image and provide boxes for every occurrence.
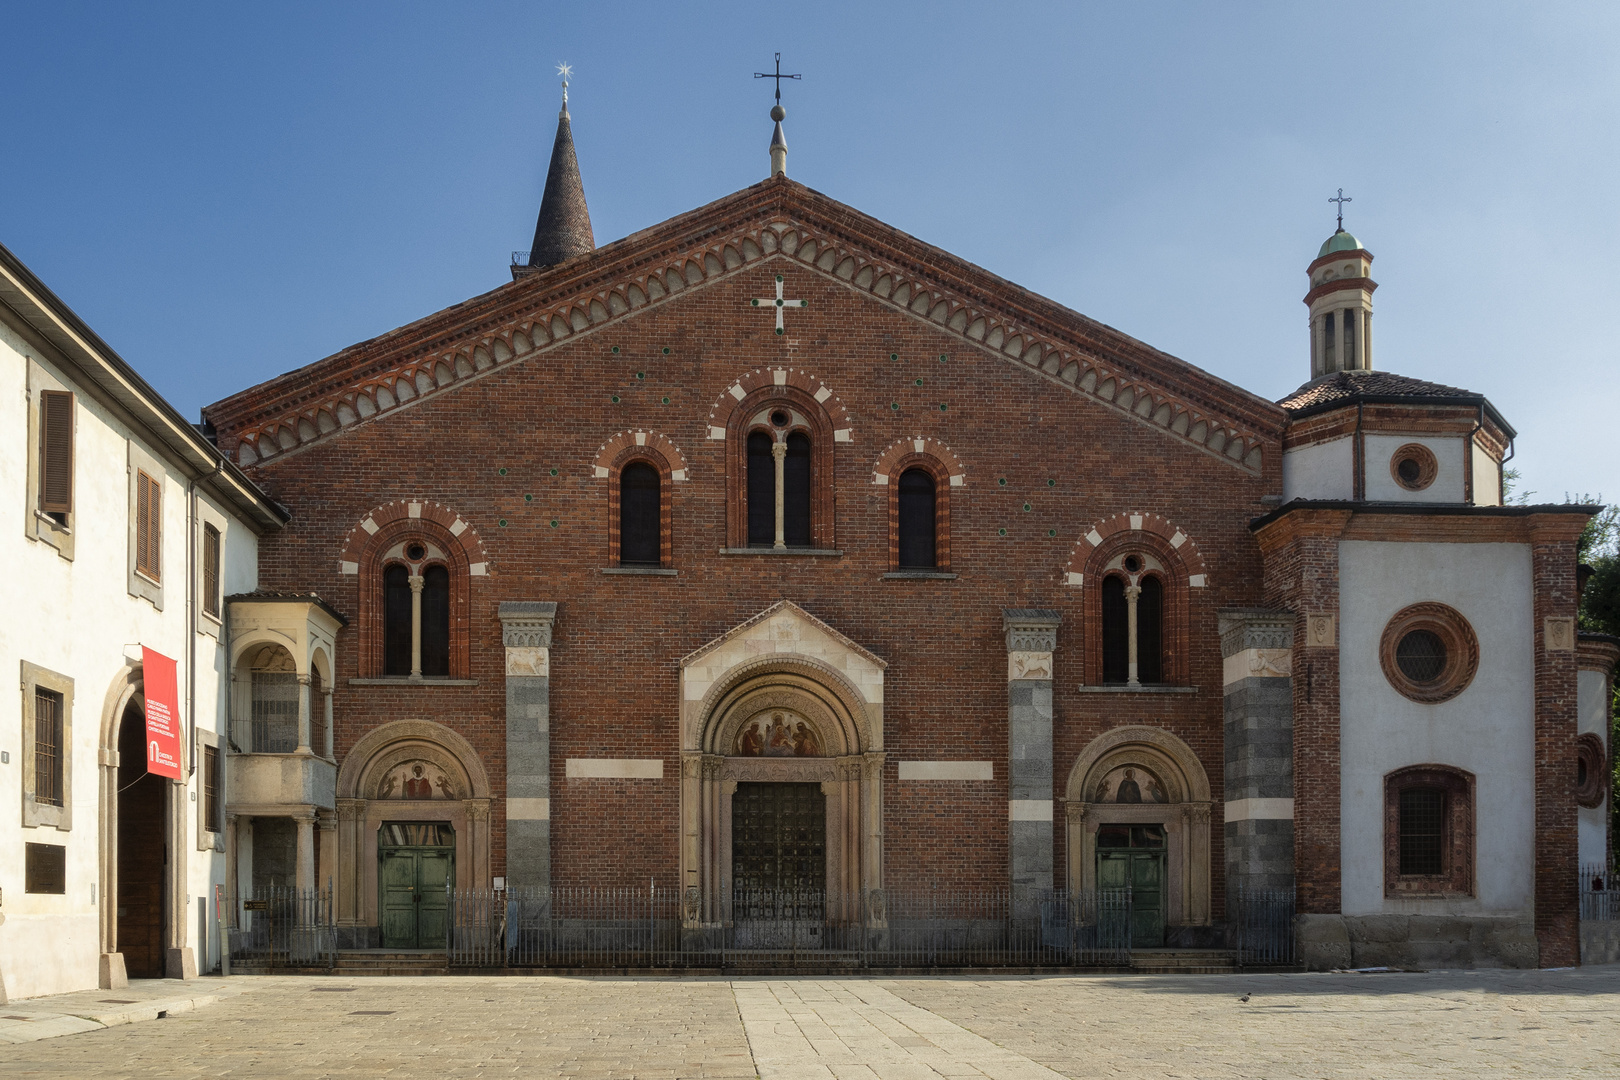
[0,246,285,1001]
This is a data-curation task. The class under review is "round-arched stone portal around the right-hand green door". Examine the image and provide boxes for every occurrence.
[1066,725,1210,946]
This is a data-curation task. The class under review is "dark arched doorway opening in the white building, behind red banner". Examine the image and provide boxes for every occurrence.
[117,699,172,978]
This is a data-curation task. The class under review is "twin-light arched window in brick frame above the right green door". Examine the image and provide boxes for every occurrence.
[1069,529,1202,687]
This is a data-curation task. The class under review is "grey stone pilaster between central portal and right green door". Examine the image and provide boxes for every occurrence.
[1001,607,1063,889]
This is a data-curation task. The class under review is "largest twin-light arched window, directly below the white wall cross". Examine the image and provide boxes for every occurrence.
[724,385,834,551]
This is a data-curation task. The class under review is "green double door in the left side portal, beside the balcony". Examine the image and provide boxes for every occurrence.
[377,823,455,949]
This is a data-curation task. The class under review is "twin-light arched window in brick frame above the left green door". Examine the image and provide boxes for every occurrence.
[340,500,488,680]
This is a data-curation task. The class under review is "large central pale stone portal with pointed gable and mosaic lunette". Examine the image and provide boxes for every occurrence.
[680,601,886,926]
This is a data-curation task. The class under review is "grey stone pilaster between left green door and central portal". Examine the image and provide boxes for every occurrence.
[499,601,557,889]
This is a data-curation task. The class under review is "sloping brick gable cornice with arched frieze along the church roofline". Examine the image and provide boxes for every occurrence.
[204,176,1286,473]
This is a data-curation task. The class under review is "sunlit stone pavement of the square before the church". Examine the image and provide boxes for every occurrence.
[0,967,1620,1080]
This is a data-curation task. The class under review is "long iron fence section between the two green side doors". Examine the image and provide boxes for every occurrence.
[449,886,1131,972]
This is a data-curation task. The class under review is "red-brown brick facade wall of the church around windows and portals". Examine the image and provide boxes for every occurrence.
[222,259,1270,893]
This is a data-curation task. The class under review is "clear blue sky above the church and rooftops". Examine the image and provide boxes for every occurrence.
[0,0,1620,502]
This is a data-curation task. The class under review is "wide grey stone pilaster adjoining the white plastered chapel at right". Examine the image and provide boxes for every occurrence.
[1220,610,1294,895]
